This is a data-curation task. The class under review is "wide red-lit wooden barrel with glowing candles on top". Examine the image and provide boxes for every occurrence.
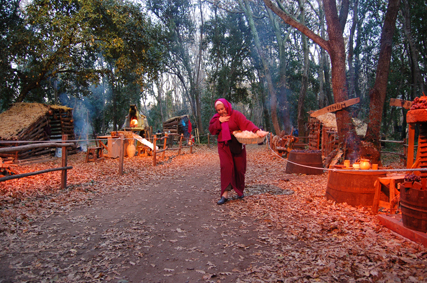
[326,170,386,206]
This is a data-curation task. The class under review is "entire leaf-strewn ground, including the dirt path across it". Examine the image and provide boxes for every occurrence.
[0,146,427,283]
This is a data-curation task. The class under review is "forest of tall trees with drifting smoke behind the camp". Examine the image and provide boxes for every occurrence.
[0,0,427,143]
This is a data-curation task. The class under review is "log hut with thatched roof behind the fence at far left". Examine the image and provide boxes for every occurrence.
[0,103,77,160]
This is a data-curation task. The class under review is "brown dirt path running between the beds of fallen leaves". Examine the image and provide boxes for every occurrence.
[0,145,284,282]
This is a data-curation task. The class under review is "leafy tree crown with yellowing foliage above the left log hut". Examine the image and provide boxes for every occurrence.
[3,0,161,102]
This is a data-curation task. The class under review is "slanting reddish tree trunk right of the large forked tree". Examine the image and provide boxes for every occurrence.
[366,0,400,146]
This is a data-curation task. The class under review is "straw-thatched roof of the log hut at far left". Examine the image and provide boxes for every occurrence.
[0,102,71,140]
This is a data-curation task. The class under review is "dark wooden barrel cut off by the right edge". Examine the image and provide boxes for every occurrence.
[400,182,427,232]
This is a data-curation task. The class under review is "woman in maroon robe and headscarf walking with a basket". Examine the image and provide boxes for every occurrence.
[209,98,267,204]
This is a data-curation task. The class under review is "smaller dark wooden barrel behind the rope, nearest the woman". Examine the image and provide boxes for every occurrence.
[286,150,323,175]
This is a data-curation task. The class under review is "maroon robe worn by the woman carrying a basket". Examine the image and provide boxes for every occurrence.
[209,101,259,196]
